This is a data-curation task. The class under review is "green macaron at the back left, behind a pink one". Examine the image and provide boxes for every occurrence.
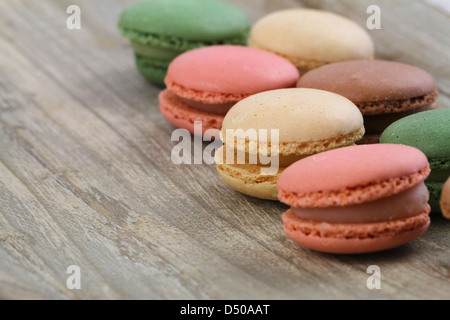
[118,0,250,85]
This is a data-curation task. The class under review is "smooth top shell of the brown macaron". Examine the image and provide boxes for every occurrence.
[297,60,436,105]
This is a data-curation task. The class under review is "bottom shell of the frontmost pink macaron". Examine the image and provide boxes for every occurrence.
[282,207,430,254]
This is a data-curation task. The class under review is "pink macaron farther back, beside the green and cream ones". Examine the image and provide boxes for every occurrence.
[159,45,300,134]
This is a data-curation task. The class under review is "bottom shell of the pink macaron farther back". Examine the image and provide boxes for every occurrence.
[158,89,223,137]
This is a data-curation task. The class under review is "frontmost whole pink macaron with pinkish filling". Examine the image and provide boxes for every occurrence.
[278,144,430,254]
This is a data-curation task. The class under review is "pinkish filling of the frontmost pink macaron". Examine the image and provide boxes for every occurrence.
[291,182,429,223]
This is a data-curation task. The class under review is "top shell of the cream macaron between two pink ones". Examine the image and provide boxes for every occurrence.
[222,89,364,147]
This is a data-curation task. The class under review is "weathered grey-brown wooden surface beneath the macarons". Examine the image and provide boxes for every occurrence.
[0,0,450,299]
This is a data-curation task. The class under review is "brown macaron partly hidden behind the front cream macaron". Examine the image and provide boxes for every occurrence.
[297,60,438,144]
